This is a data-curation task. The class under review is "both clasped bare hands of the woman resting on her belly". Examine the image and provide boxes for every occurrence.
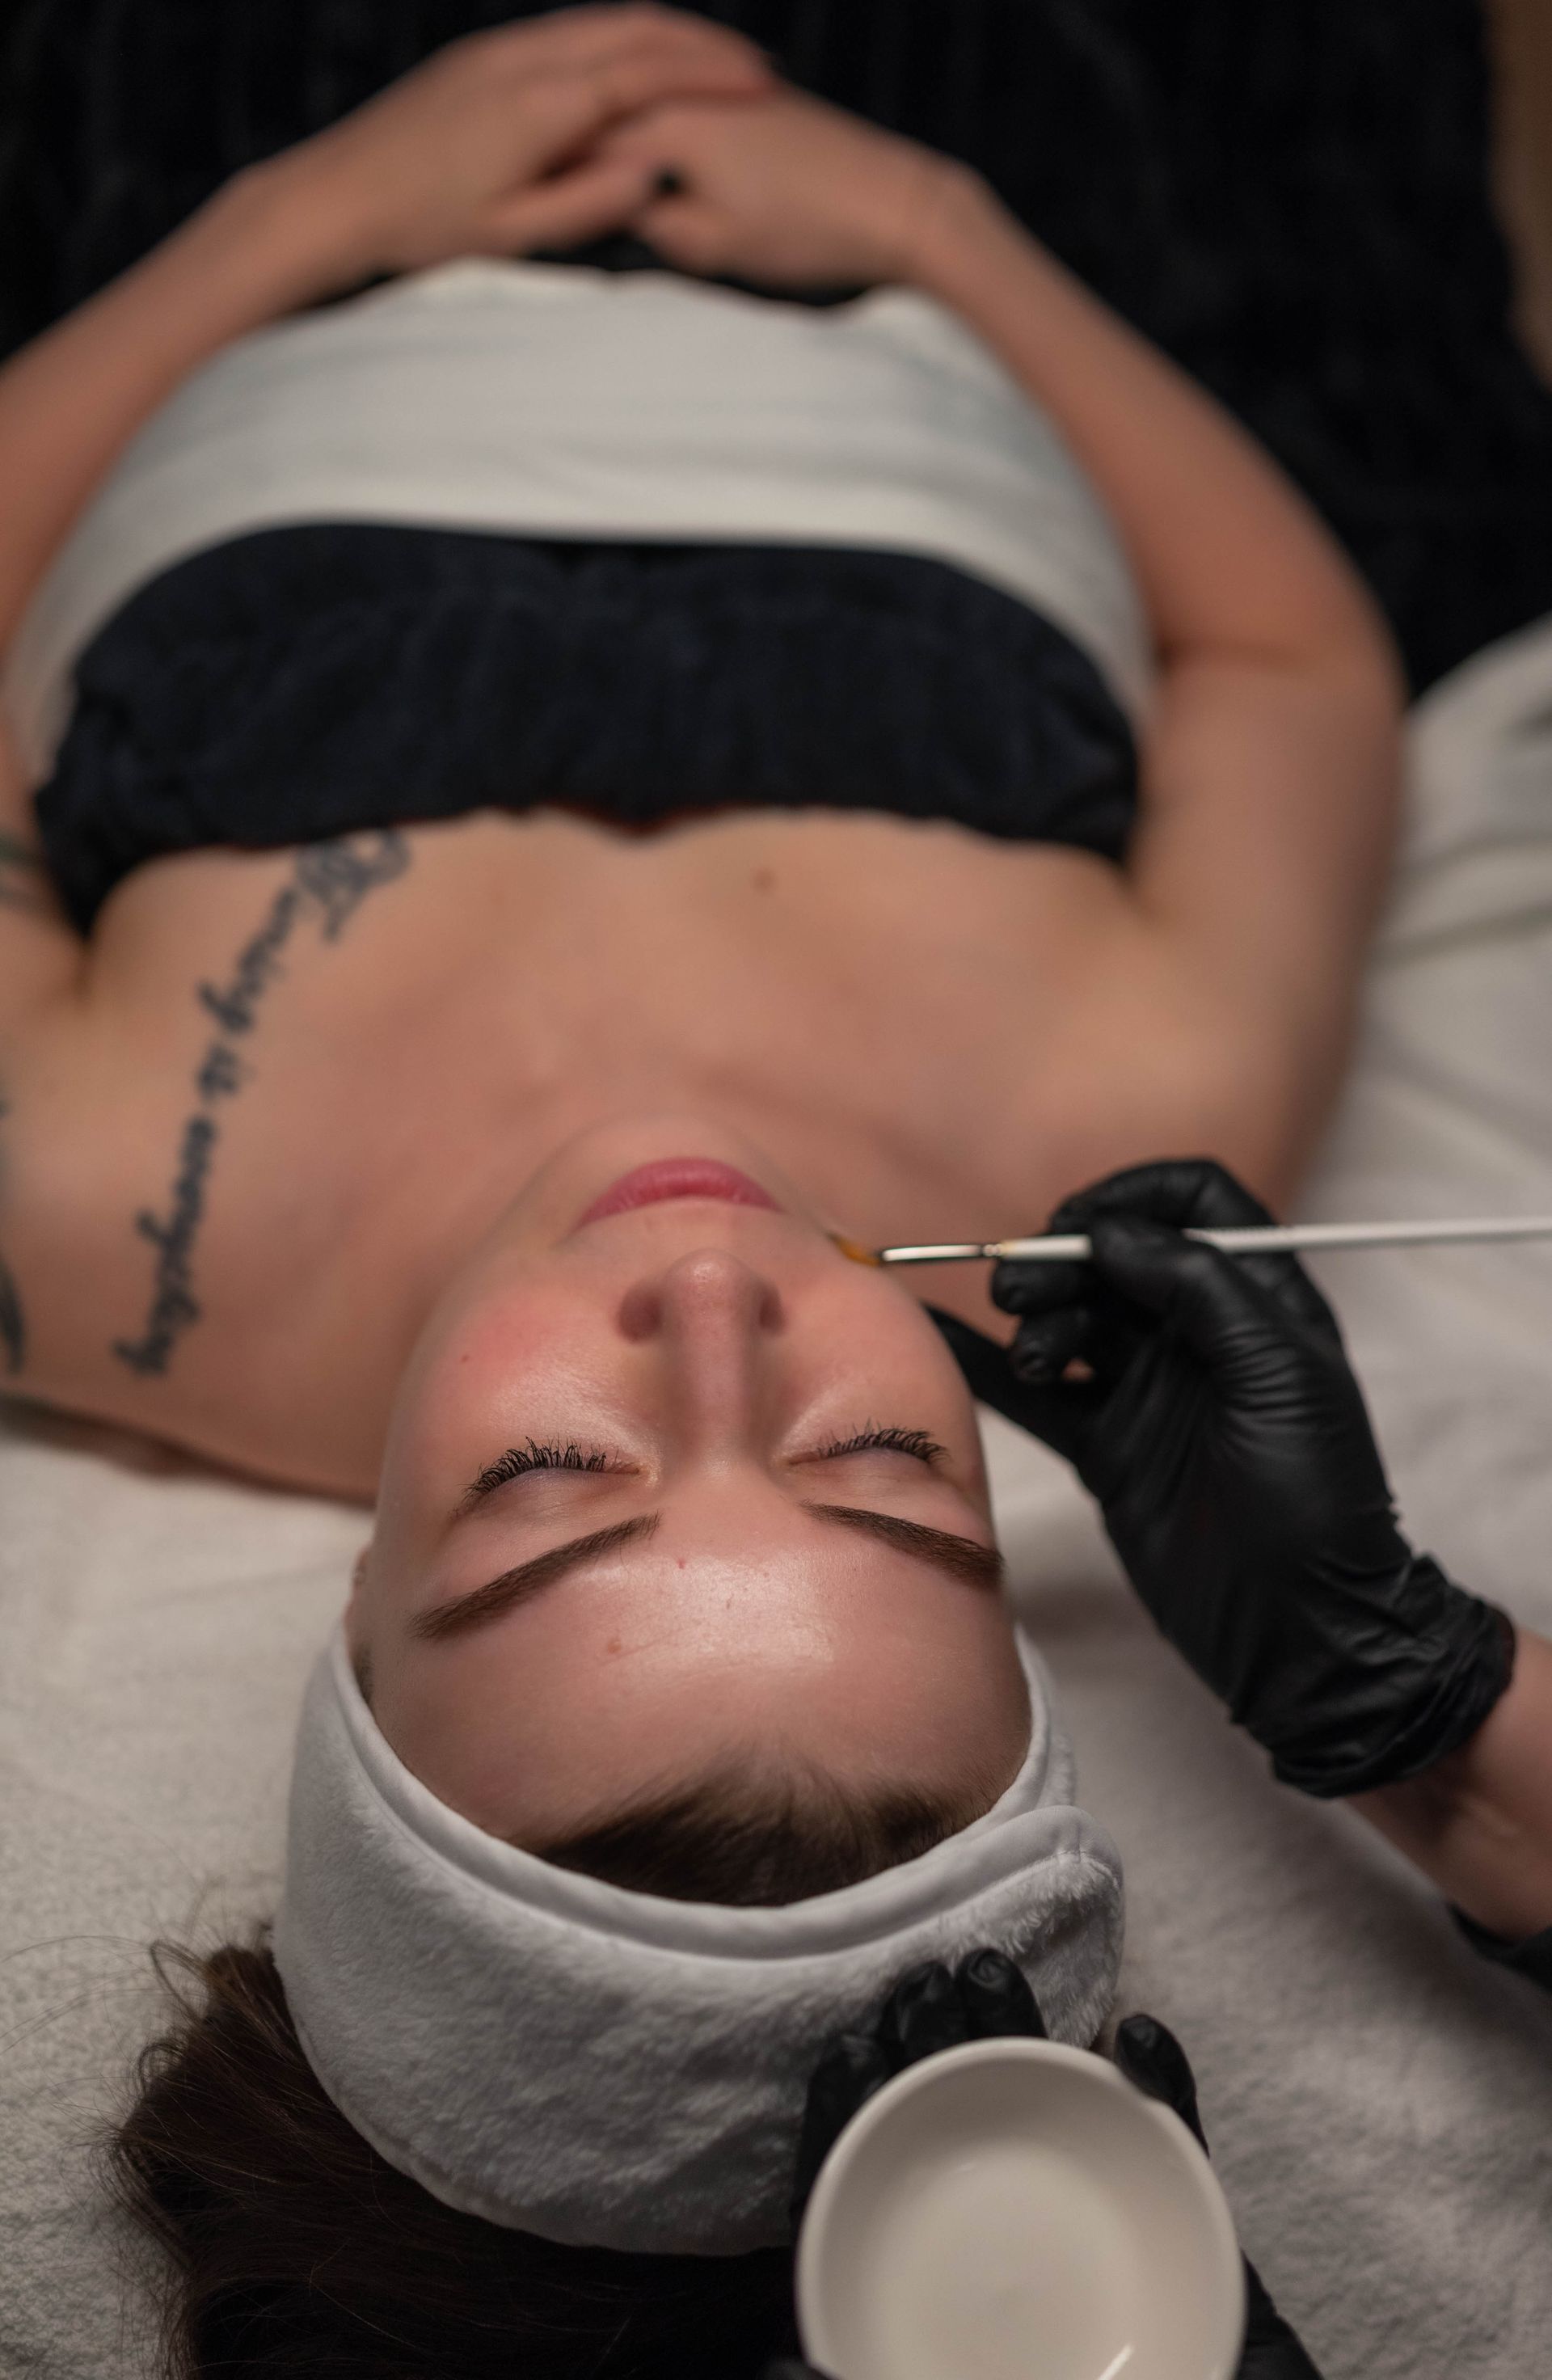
[257,5,957,288]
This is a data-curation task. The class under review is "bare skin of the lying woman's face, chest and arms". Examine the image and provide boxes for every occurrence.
[0,7,1400,1830]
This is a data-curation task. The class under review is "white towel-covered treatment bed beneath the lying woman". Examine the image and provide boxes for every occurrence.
[0,623,1552,2380]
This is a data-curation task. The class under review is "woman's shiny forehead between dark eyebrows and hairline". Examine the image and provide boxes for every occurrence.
[371,1528,1028,1840]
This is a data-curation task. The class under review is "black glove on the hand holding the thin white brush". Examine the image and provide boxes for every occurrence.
[981,1162,1514,1797]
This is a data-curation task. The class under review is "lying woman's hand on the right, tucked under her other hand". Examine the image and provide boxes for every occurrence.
[597,86,969,288]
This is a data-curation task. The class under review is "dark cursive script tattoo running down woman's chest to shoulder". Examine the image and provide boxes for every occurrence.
[112,829,410,1376]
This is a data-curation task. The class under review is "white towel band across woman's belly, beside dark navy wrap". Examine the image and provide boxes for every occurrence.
[5,260,1149,779]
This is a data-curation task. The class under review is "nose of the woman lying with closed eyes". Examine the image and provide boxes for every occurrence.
[622,1247,786,1454]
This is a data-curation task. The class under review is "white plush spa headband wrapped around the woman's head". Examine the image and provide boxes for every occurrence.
[274,1633,1121,2254]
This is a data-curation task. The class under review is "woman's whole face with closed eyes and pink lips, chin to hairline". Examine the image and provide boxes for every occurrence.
[348,1119,1028,1849]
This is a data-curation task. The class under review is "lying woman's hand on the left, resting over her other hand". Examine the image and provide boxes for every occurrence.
[250,5,771,285]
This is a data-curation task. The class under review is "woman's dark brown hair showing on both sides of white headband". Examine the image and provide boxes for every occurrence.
[108,1780,990,2380]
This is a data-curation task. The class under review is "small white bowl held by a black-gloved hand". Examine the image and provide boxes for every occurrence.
[798,2040,1245,2380]
